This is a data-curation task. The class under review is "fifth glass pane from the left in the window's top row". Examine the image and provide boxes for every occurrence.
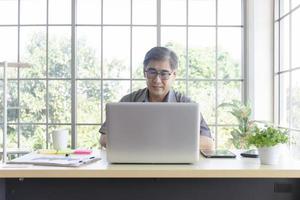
[103,0,130,24]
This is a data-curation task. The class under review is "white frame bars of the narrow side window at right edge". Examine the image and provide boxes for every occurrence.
[274,0,300,144]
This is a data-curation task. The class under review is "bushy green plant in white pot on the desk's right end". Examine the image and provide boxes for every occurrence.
[247,126,289,165]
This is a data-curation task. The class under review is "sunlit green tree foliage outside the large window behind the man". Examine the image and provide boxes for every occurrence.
[0,30,241,149]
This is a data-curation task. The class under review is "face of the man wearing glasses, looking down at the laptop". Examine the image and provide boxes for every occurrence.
[145,60,176,99]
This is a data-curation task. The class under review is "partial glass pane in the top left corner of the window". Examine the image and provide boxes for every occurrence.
[0,0,18,24]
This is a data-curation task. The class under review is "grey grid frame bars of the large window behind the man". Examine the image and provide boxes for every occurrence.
[0,0,248,148]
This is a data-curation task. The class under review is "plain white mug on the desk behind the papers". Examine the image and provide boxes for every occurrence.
[52,129,69,150]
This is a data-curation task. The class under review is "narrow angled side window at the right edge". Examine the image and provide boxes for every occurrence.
[274,0,300,157]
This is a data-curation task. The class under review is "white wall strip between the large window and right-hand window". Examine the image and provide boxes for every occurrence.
[245,0,274,121]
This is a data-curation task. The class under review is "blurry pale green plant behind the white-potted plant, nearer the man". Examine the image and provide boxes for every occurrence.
[219,100,256,149]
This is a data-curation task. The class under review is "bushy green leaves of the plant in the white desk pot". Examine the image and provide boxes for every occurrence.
[247,126,289,148]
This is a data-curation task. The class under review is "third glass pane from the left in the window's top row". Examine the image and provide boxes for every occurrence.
[48,0,72,24]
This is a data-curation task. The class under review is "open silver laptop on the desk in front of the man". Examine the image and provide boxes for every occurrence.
[106,103,200,163]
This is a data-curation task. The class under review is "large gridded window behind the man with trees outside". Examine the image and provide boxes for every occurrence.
[0,0,244,151]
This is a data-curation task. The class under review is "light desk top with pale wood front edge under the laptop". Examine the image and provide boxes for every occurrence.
[0,152,300,178]
